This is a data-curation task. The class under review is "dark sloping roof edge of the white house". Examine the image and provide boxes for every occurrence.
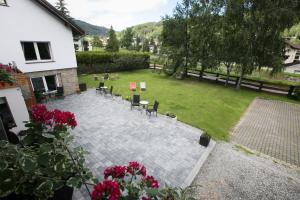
[35,0,85,36]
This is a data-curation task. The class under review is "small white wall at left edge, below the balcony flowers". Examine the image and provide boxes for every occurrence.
[0,88,29,133]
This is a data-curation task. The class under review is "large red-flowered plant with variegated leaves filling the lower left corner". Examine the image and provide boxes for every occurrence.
[0,105,92,200]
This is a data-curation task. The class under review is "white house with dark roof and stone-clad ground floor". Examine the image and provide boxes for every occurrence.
[0,0,84,95]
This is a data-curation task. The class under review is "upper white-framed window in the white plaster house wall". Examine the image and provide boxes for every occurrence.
[21,42,52,62]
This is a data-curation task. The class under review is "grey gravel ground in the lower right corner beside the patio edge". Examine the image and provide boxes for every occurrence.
[193,143,300,200]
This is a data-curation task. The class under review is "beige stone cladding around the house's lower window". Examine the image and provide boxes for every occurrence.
[27,68,79,95]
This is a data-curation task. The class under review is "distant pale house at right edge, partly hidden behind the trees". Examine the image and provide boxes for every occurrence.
[284,42,300,65]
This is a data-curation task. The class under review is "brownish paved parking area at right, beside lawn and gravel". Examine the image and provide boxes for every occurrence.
[233,99,300,167]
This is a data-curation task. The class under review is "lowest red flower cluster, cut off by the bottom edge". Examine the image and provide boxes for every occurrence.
[92,180,121,200]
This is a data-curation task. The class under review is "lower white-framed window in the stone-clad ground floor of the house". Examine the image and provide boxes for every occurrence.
[31,75,59,92]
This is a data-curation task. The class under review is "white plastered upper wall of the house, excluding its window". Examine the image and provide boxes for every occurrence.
[0,0,77,73]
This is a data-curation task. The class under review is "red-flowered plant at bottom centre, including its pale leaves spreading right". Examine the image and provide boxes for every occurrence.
[92,162,194,200]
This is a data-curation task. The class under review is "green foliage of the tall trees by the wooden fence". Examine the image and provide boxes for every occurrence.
[162,0,300,88]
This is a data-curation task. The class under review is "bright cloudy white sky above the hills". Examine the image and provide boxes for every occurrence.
[48,0,179,31]
